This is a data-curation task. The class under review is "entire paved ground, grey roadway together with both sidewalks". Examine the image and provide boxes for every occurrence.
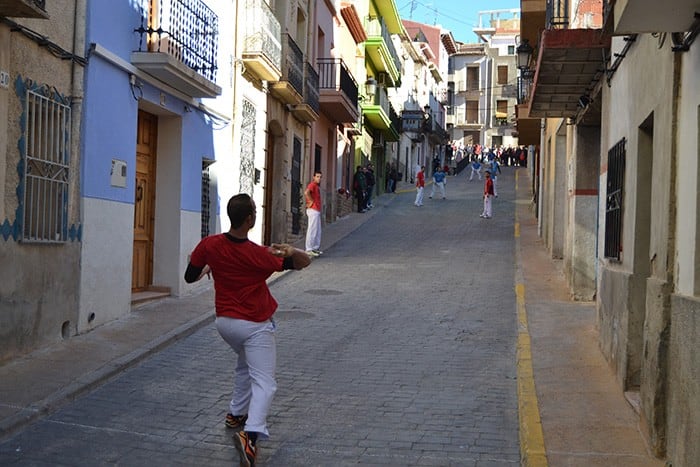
[0,168,662,467]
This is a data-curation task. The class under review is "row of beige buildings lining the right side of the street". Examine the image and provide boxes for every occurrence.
[518,0,700,466]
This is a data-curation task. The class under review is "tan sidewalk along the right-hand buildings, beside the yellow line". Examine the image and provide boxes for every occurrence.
[508,169,664,467]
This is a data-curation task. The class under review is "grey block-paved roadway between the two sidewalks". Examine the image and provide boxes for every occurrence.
[0,169,519,466]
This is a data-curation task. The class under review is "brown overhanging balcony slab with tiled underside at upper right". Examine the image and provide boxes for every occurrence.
[529,29,610,118]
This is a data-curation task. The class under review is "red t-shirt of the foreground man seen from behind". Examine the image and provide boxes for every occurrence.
[190,234,284,323]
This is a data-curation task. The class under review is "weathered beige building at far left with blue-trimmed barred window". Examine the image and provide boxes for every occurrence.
[0,0,86,361]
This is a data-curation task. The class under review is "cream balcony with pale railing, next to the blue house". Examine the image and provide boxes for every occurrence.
[242,0,282,81]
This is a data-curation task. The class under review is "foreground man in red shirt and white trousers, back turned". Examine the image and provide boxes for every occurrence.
[185,193,311,465]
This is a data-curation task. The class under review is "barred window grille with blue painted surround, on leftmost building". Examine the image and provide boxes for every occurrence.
[21,90,71,243]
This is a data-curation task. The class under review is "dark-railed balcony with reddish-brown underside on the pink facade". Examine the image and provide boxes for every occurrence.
[317,58,360,123]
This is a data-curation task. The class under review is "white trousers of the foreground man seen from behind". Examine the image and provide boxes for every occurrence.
[216,316,277,439]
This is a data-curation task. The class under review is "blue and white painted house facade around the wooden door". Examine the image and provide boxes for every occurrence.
[80,0,230,327]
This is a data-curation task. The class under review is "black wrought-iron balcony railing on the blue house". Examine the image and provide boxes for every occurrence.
[134,0,219,82]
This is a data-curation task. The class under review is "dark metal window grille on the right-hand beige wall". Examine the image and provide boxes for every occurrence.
[605,138,626,260]
